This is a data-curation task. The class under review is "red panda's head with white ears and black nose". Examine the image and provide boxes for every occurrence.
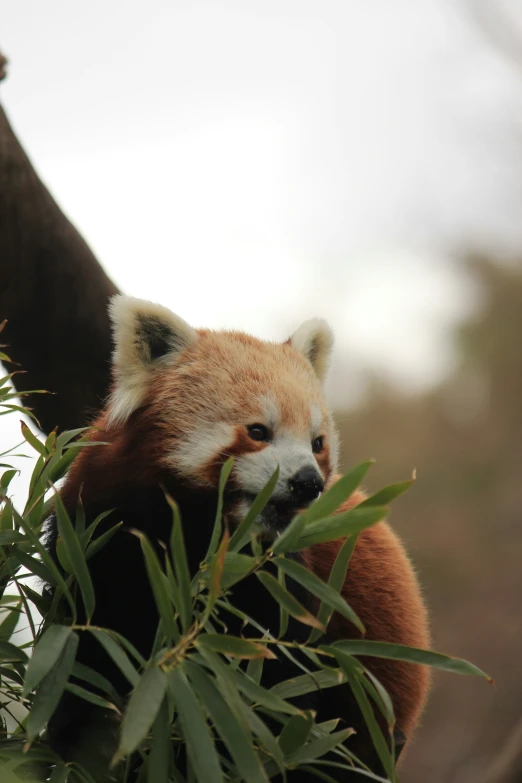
[105,296,337,532]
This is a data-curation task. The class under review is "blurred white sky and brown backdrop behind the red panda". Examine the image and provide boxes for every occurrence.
[0,0,522,783]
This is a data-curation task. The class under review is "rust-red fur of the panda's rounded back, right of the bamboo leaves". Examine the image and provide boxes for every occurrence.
[303,492,430,738]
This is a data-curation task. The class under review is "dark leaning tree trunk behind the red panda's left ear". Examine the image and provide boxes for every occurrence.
[0,55,118,432]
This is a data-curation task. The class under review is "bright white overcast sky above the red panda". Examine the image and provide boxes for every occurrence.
[0,0,522,428]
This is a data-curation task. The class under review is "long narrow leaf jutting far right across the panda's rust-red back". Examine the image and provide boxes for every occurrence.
[320,639,493,682]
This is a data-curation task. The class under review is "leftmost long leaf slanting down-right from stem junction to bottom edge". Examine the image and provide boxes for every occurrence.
[169,668,224,783]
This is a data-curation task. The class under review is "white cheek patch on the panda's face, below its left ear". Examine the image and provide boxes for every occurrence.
[167,421,235,476]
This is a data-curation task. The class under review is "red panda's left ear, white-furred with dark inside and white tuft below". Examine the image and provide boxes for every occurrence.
[108,294,198,425]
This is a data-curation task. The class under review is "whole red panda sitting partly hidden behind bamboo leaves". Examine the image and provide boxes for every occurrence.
[44,296,428,781]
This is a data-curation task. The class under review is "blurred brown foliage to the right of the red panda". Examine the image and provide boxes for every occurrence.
[338,257,522,783]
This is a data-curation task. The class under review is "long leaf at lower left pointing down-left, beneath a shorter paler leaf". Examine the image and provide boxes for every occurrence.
[26,632,78,741]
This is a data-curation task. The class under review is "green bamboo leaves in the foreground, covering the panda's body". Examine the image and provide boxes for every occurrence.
[0,364,486,783]
